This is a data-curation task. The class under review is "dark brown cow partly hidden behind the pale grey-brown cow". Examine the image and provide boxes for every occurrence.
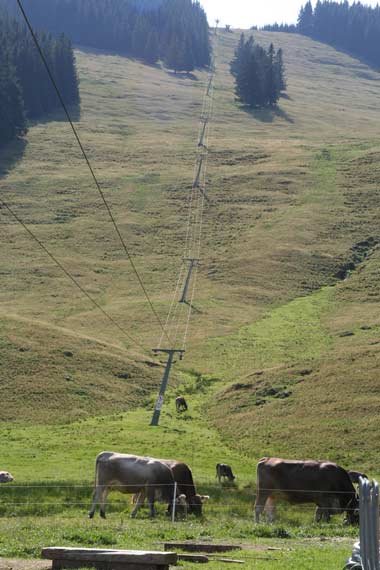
[133,459,210,517]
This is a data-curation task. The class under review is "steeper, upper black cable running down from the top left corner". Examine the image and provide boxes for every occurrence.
[16,0,166,342]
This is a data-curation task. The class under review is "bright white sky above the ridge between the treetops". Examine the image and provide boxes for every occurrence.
[200,0,379,29]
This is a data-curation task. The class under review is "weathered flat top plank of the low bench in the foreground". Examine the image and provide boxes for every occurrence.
[42,546,177,565]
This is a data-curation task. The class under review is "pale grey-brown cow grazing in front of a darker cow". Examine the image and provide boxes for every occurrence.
[89,451,174,518]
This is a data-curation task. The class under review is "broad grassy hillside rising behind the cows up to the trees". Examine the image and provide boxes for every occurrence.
[0,27,380,480]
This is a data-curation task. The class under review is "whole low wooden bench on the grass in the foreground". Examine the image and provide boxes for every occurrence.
[42,547,178,570]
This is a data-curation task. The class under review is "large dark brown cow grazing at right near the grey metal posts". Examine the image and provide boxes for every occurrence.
[255,457,359,524]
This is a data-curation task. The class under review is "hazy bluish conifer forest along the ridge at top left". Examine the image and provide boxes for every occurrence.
[0,0,211,72]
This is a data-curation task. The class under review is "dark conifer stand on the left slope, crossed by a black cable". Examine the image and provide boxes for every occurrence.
[0,10,79,145]
